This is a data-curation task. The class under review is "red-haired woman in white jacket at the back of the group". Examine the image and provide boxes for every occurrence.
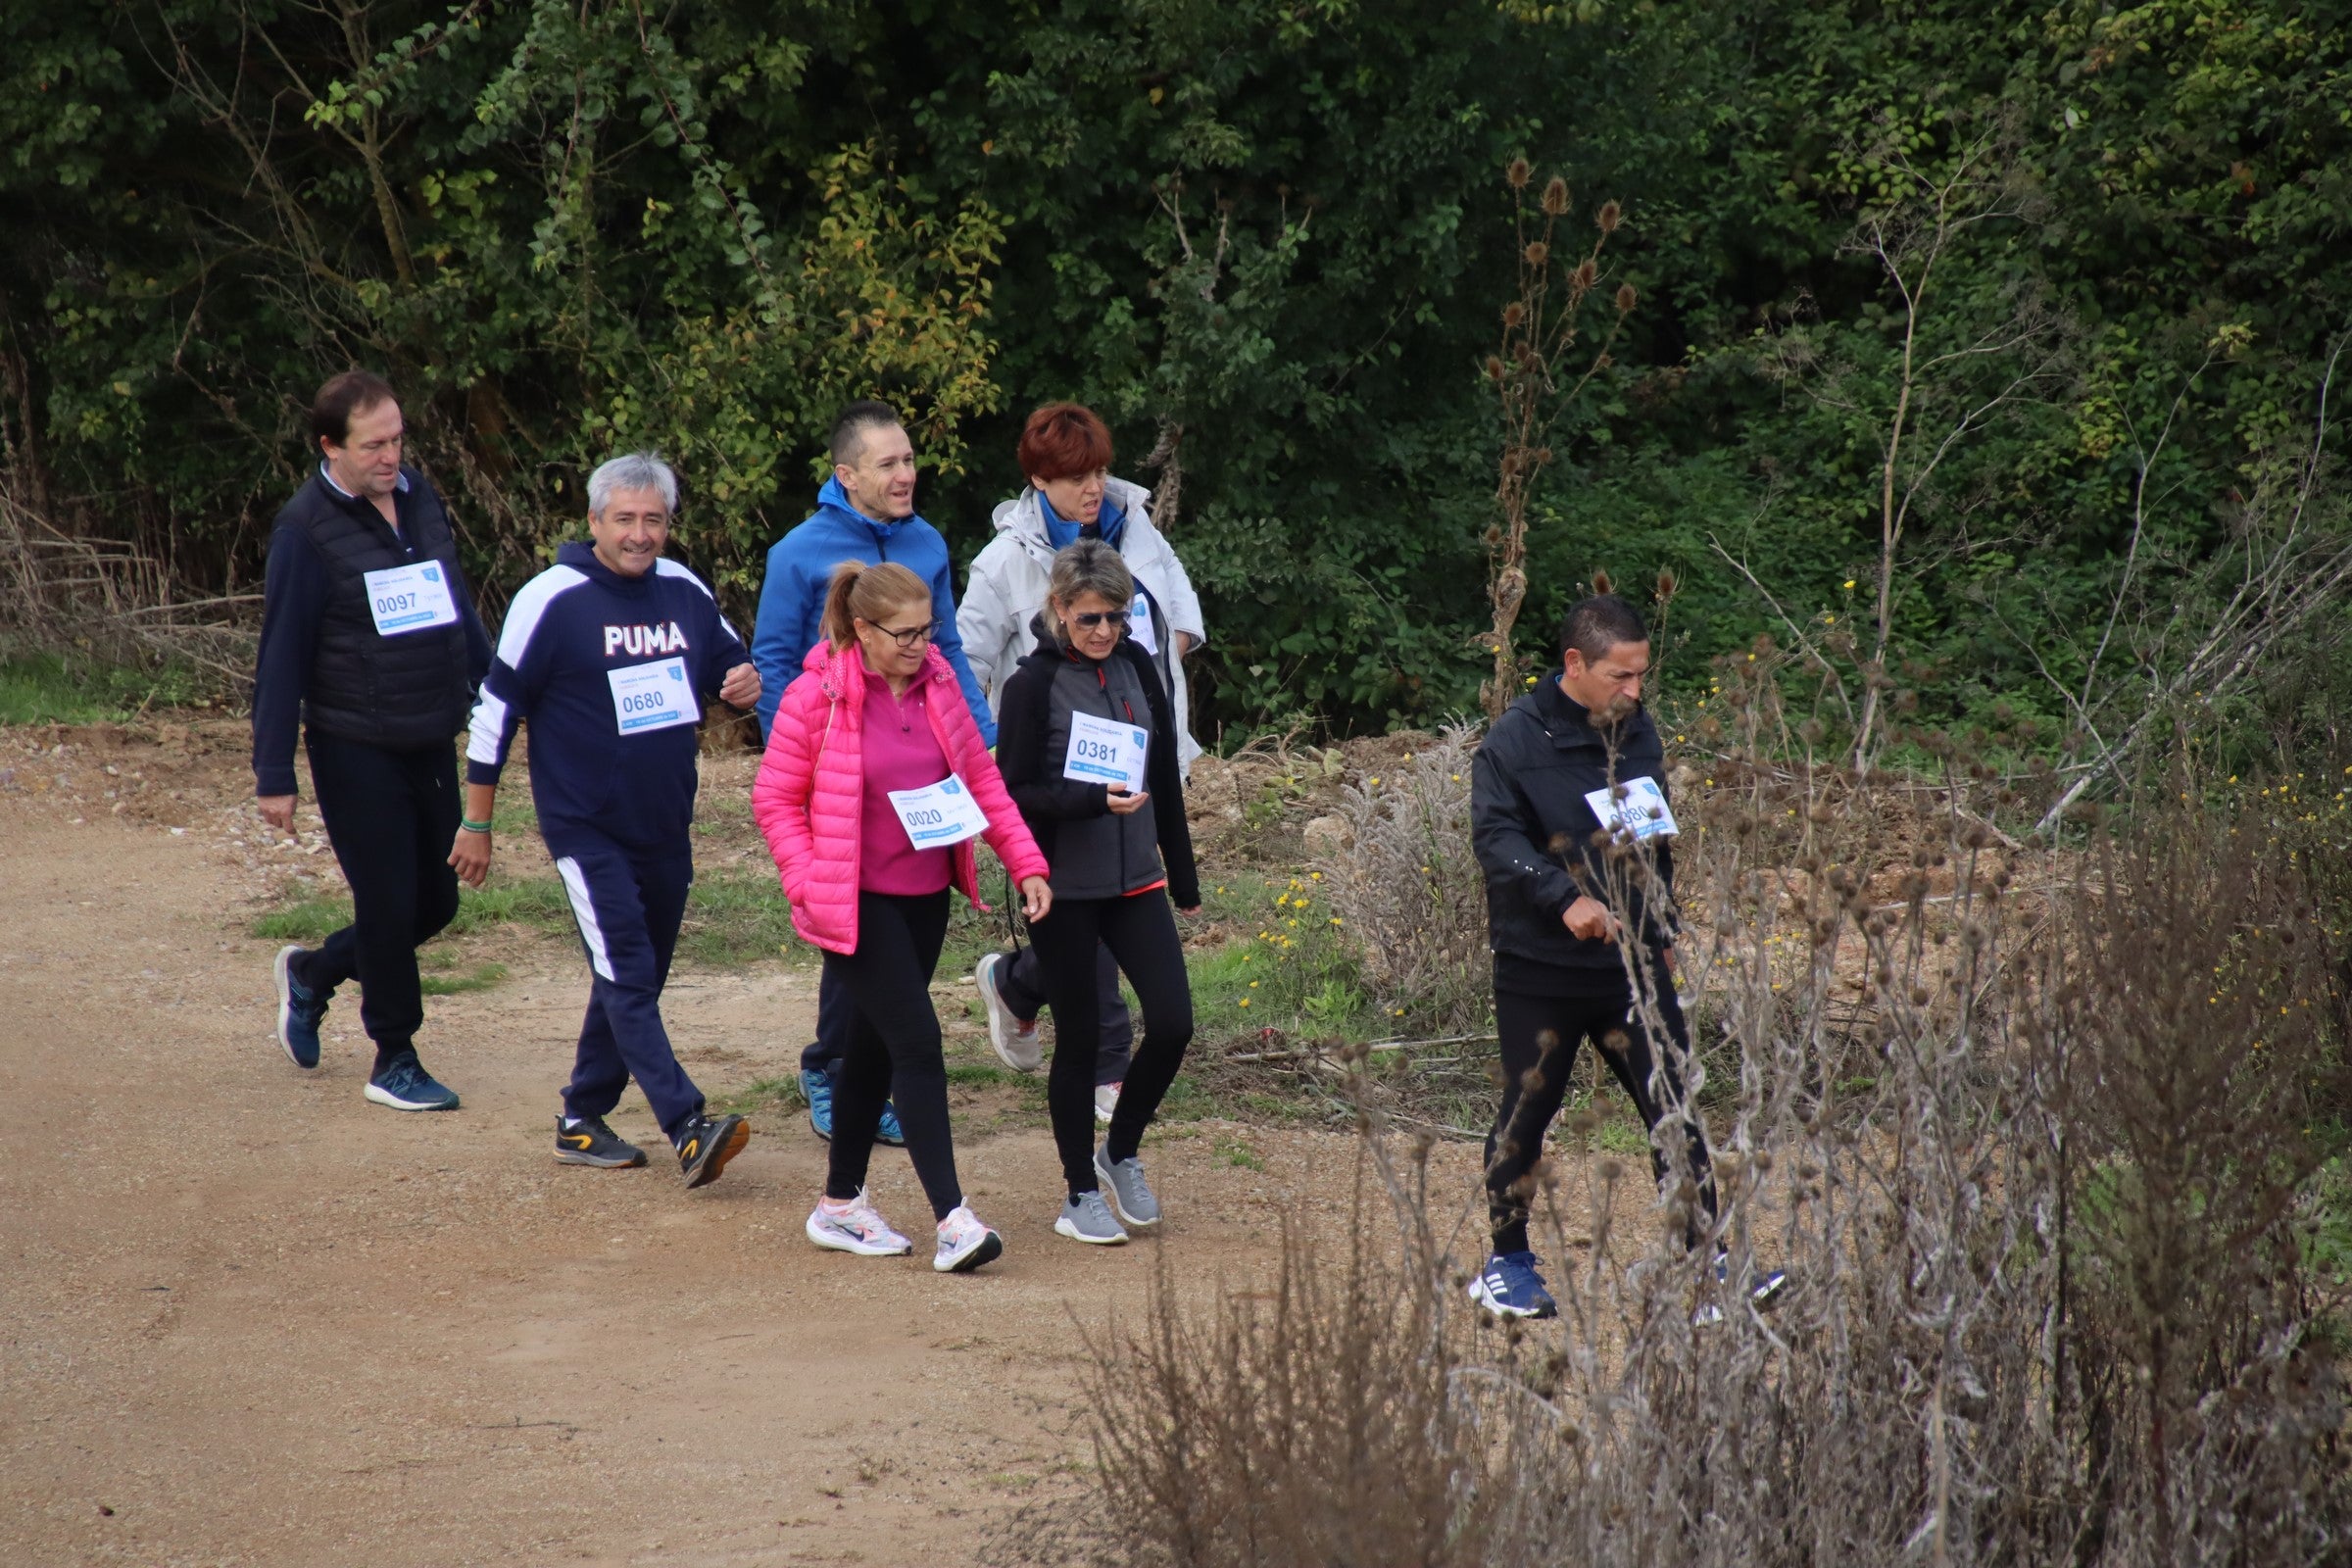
[955,402,1206,1121]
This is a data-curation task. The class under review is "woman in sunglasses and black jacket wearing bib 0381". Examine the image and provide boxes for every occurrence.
[998,538,1200,1246]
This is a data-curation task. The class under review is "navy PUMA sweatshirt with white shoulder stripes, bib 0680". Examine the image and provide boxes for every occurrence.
[466,543,748,854]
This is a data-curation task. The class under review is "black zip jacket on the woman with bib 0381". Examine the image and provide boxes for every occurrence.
[998,615,1200,909]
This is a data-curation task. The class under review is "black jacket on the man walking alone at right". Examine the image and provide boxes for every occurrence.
[1470,670,1675,983]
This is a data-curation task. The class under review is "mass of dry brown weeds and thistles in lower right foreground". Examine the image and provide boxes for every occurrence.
[1039,676,2352,1568]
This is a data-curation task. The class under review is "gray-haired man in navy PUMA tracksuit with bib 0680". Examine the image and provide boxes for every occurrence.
[449,452,760,1187]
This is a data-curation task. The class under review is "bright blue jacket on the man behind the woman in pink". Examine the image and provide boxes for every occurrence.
[751,479,998,745]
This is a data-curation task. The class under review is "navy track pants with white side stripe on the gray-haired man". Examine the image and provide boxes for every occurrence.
[548,827,704,1138]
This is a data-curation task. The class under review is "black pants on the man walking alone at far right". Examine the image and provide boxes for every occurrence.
[1487,976,1715,1253]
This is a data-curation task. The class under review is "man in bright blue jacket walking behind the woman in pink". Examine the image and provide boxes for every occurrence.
[751,400,998,1145]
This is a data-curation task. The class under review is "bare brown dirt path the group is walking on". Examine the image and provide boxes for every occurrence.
[0,780,1392,1568]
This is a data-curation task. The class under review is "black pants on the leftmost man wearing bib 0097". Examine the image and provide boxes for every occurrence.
[294,729,459,1057]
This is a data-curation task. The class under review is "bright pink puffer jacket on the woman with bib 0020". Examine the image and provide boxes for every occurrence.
[751,642,1049,953]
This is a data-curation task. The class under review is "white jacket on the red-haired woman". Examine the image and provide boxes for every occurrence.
[955,479,1209,773]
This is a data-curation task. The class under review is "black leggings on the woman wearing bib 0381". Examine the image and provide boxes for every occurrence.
[1030,889,1193,1197]
